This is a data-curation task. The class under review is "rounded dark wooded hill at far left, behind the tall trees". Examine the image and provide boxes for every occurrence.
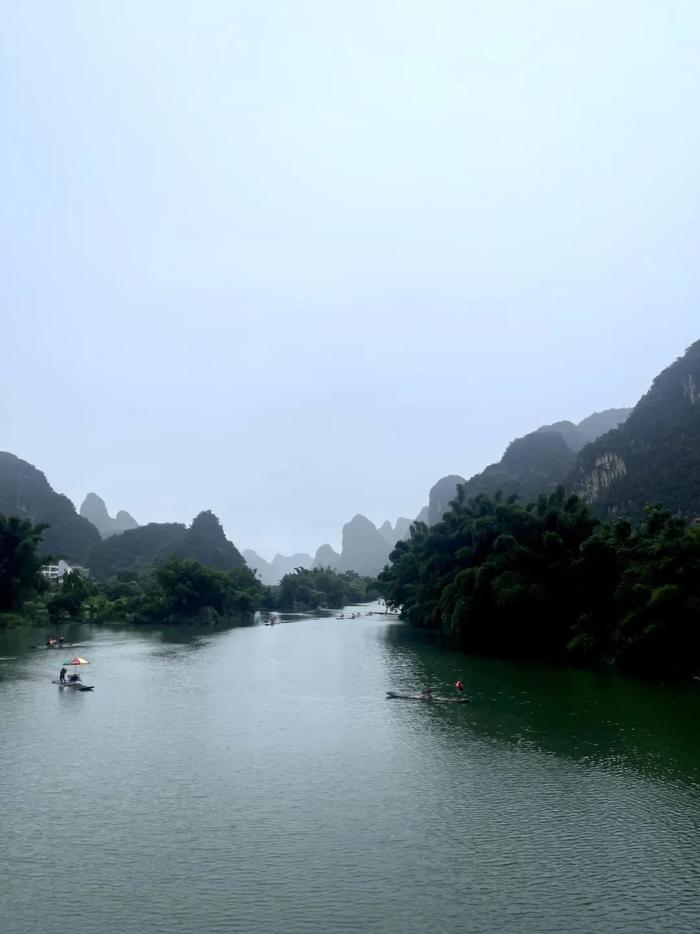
[0,452,100,563]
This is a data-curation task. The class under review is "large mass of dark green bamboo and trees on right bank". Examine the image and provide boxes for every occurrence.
[379,487,700,675]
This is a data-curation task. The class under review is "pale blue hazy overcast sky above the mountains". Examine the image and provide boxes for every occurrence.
[0,0,700,558]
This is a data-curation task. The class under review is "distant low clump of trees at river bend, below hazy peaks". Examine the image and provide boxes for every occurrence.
[266,568,378,610]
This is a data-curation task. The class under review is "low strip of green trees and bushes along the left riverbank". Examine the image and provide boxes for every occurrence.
[0,515,378,628]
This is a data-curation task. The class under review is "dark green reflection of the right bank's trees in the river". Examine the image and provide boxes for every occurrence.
[382,624,700,782]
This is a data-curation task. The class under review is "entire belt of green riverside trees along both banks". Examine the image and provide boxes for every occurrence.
[0,494,700,677]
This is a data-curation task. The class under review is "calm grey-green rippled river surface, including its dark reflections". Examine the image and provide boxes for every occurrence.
[0,616,700,934]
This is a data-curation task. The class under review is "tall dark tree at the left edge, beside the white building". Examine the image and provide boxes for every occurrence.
[0,515,45,613]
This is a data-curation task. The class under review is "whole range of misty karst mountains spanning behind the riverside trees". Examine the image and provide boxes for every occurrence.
[0,341,700,584]
